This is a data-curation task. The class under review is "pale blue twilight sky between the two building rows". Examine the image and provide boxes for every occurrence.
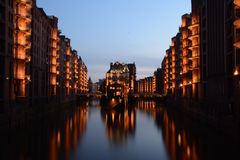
[37,0,191,81]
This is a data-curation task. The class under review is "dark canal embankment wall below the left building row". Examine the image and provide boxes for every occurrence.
[0,96,88,131]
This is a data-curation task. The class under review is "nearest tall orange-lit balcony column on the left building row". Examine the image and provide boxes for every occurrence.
[12,0,33,100]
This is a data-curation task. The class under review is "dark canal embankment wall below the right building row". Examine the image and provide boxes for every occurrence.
[166,97,240,141]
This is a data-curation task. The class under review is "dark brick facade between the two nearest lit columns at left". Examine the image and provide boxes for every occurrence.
[30,7,57,105]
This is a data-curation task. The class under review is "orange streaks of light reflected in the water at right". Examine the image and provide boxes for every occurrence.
[137,100,200,160]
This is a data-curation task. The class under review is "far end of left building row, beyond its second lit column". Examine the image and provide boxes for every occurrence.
[59,35,88,99]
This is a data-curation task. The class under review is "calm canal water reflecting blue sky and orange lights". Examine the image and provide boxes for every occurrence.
[0,100,240,160]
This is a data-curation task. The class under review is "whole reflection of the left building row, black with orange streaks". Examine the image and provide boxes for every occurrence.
[0,102,88,160]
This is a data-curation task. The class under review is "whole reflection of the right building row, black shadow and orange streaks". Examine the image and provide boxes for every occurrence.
[137,100,239,160]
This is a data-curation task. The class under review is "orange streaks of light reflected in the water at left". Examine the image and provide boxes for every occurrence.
[49,107,88,160]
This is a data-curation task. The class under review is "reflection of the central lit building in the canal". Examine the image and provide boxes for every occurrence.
[101,108,136,144]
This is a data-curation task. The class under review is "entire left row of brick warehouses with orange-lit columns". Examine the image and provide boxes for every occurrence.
[0,0,88,114]
